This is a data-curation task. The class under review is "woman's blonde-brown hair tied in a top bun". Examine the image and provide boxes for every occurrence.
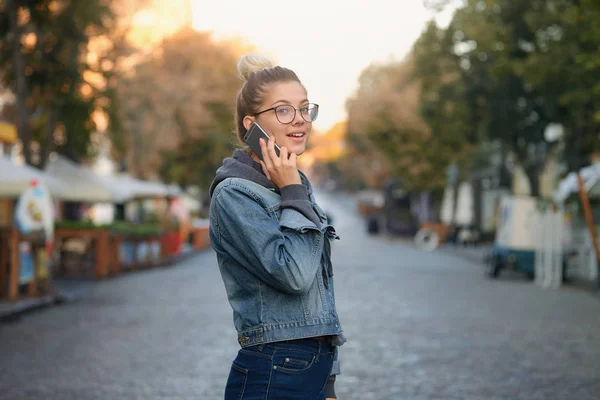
[235,53,306,144]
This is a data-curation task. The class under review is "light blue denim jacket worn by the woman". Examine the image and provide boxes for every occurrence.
[210,151,344,374]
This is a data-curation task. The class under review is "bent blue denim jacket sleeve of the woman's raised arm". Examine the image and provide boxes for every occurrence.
[211,184,324,295]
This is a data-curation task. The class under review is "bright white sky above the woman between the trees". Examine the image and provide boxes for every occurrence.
[190,0,451,131]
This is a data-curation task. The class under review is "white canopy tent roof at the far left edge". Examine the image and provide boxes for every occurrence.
[0,156,67,199]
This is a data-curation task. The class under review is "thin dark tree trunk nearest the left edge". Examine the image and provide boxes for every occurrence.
[7,0,31,164]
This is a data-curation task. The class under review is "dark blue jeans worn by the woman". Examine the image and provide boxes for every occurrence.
[225,339,334,400]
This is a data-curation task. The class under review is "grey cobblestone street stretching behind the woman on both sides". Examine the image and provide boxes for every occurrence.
[0,194,600,400]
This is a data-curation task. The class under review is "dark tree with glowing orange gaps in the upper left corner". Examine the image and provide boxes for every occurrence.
[0,0,118,166]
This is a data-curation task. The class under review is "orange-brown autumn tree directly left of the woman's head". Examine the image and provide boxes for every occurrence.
[110,29,249,187]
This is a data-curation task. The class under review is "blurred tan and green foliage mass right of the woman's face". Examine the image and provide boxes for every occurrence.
[347,28,477,190]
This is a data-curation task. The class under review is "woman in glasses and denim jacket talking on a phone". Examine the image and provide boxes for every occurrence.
[210,54,345,400]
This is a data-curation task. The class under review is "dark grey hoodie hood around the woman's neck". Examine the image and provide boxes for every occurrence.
[210,150,312,197]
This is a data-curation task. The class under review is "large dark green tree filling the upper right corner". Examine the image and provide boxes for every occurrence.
[419,0,600,196]
